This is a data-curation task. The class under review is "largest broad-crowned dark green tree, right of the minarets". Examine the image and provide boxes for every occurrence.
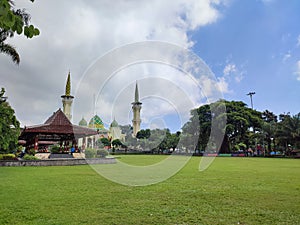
[182,100,262,153]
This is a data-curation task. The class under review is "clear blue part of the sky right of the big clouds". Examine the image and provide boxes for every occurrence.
[190,0,300,114]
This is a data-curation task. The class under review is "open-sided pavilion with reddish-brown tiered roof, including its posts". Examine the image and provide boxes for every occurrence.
[19,109,97,151]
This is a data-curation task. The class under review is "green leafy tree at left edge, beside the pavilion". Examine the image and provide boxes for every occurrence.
[0,88,20,153]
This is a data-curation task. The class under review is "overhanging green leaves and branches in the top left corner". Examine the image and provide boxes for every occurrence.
[0,0,40,64]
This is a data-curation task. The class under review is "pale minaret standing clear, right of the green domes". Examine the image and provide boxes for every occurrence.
[131,82,142,137]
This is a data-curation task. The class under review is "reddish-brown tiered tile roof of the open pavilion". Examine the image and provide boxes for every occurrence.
[19,109,97,141]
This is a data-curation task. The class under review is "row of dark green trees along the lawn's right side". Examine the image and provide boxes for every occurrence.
[182,100,300,154]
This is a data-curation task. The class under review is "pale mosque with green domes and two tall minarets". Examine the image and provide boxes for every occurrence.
[61,72,142,149]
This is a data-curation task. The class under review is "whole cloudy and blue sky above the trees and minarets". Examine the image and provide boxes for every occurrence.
[0,0,300,131]
